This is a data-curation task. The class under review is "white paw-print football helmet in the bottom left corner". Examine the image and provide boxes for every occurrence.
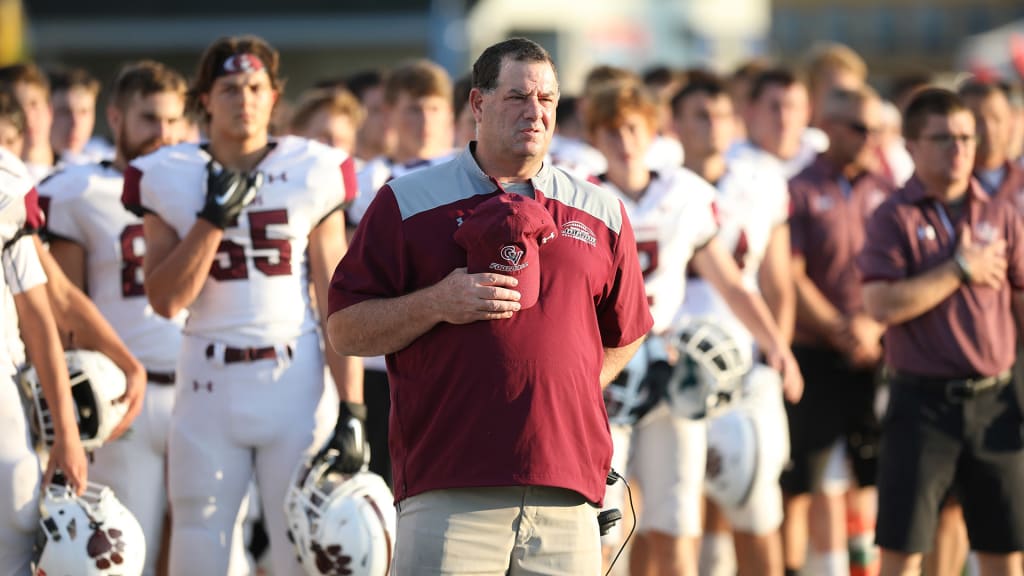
[32,483,145,576]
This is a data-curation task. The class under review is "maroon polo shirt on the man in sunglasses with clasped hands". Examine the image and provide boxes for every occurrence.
[790,155,893,343]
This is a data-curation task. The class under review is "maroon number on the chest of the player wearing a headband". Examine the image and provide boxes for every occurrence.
[210,210,292,281]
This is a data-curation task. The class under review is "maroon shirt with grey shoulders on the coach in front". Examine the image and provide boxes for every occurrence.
[329,144,651,502]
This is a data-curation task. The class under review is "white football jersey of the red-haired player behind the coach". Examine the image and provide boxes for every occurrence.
[601,168,718,333]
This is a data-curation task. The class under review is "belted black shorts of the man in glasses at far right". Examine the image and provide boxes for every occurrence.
[877,375,1024,553]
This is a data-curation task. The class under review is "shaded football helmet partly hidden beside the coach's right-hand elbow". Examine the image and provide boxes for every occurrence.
[604,334,672,425]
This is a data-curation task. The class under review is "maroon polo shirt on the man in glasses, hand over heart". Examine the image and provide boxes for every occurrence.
[857,176,1024,378]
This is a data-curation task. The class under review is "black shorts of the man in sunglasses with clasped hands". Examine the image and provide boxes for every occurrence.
[781,346,881,494]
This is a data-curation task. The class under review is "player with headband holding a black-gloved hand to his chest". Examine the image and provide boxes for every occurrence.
[122,36,367,576]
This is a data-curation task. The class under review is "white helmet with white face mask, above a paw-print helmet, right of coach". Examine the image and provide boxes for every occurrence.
[667,319,751,419]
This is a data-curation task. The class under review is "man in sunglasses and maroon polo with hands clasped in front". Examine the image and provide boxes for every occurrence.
[782,87,892,574]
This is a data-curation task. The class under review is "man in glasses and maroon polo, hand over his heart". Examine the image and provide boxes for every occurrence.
[857,88,1024,575]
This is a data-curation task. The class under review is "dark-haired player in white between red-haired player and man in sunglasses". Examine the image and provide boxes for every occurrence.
[672,73,795,574]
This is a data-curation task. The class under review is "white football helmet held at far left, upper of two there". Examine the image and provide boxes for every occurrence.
[20,349,128,450]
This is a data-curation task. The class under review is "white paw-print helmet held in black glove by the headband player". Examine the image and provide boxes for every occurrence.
[285,440,396,576]
